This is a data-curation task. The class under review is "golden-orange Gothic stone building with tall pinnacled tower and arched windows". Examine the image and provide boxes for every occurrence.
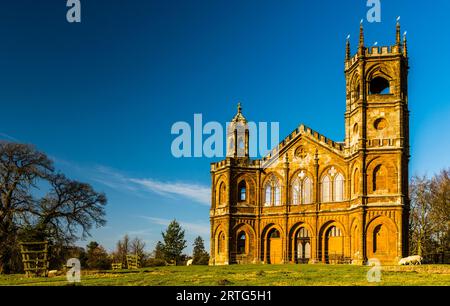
[210,25,409,265]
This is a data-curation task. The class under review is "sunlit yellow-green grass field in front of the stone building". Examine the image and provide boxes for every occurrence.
[0,265,450,286]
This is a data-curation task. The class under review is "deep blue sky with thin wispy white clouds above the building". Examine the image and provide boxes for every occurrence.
[0,0,450,252]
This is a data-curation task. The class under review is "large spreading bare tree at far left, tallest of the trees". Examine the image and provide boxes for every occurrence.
[0,142,106,273]
